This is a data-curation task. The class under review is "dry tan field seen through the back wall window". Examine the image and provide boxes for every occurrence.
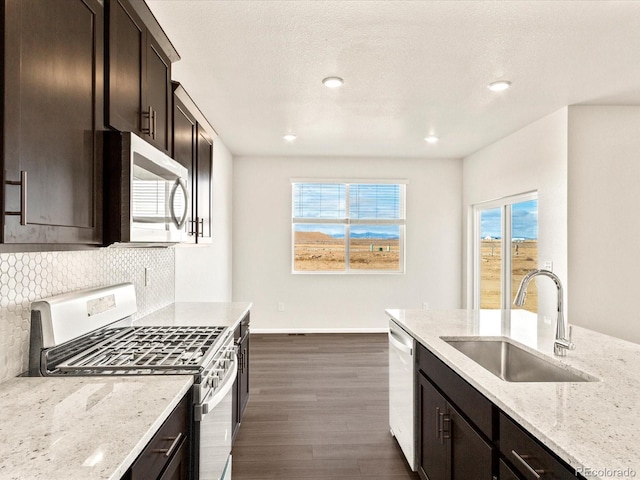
[294,232,400,271]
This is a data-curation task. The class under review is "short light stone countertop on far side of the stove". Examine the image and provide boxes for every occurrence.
[133,302,252,329]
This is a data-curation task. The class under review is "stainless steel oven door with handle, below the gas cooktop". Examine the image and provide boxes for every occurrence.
[195,356,238,480]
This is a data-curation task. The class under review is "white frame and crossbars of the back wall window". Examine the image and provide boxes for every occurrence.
[290,178,409,275]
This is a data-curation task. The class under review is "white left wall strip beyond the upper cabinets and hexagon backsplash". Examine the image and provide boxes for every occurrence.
[175,138,233,302]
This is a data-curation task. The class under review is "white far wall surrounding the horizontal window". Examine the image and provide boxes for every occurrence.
[233,158,461,331]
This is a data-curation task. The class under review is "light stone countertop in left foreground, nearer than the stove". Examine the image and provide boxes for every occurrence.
[0,375,193,480]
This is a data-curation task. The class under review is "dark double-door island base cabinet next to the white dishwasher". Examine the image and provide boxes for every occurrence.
[418,374,493,480]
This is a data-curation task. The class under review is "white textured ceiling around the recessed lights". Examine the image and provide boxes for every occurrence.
[147,0,640,158]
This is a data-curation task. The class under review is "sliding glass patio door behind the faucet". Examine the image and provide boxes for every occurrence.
[473,193,538,312]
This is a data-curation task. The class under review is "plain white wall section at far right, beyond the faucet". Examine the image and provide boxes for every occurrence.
[569,106,640,343]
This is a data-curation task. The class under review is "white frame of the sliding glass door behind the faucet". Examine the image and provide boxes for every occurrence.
[471,190,538,310]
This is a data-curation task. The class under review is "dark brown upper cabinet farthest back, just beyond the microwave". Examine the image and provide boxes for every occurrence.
[173,82,216,243]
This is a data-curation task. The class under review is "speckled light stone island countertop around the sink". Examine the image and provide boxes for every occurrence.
[386,309,640,479]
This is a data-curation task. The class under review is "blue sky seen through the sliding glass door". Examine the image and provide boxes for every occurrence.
[480,200,538,239]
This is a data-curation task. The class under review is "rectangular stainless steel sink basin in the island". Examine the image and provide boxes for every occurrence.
[441,337,598,382]
